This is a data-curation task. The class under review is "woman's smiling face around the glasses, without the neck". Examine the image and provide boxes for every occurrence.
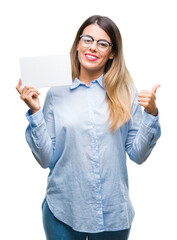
[77,24,113,75]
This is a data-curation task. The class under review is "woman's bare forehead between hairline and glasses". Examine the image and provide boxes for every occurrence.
[82,24,111,42]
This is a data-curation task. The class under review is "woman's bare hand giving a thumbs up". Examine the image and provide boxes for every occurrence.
[138,84,160,116]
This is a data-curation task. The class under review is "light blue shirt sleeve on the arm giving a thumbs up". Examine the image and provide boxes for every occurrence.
[125,91,161,164]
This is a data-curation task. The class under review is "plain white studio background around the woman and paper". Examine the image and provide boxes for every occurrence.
[0,0,177,240]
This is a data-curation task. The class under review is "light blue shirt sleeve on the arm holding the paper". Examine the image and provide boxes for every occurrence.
[25,90,56,168]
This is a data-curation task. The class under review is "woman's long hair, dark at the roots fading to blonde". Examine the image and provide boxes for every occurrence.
[70,15,134,132]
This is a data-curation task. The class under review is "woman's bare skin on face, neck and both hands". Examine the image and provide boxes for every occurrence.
[16,24,160,116]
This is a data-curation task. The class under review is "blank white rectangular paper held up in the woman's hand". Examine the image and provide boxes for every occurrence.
[20,54,72,88]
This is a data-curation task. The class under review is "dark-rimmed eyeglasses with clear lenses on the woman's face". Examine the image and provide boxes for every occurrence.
[80,35,113,52]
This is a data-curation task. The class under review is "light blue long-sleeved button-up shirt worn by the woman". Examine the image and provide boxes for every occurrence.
[26,76,160,233]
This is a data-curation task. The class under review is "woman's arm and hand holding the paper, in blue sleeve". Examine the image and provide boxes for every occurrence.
[16,79,55,168]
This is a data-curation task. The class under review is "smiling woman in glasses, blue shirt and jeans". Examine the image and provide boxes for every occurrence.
[17,15,160,240]
